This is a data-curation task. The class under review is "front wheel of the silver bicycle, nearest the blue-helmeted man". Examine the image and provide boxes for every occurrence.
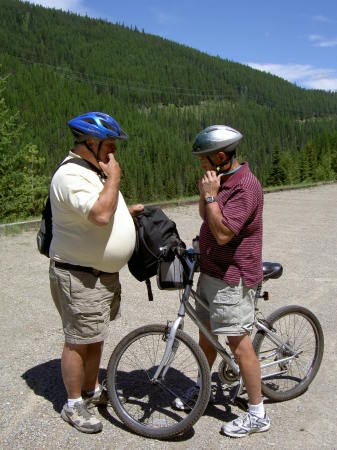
[107,324,211,439]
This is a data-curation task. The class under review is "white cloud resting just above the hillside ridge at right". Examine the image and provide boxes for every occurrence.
[248,63,337,91]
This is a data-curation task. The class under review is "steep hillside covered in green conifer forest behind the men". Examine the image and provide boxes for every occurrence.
[0,0,337,221]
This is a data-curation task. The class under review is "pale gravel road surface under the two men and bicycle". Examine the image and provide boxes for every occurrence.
[0,184,337,450]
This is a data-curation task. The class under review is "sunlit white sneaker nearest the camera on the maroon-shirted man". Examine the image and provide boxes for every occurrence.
[221,412,270,437]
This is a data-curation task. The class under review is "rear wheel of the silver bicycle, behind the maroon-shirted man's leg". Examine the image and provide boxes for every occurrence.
[253,305,324,402]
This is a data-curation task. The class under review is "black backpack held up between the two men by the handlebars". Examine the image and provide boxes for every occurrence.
[128,206,185,300]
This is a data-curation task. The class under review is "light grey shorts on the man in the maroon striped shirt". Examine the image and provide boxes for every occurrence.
[196,273,256,336]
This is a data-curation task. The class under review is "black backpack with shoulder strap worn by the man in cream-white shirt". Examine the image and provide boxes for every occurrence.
[36,158,104,258]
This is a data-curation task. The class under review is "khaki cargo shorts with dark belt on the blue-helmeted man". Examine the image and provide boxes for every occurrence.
[49,261,121,344]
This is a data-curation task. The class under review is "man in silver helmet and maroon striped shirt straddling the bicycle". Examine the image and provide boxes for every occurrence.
[175,125,270,437]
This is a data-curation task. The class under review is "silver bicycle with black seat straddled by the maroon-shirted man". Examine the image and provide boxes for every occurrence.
[107,241,324,439]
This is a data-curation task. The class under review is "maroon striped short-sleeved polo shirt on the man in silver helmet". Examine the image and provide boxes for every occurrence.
[200,163,263,287]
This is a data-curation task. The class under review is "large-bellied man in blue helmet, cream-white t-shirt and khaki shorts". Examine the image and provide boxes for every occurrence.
[49,112,144,433]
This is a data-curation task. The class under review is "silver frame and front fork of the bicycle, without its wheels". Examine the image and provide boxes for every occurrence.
[151,249,299,401]
